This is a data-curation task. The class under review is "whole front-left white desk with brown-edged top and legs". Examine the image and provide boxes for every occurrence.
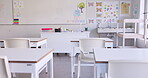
[0,48,53,78]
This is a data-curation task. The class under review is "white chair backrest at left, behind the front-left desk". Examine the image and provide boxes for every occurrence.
[4,38,30,48]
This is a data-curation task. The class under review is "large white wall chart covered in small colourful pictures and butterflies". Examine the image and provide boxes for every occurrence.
[96,1,119,23]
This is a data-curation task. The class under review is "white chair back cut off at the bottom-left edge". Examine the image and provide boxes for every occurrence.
[0,56,11,78]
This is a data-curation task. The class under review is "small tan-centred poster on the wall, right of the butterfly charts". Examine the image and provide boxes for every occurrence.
[120,1,131,16]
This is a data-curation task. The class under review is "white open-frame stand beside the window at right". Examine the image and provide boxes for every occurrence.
[117,19,147,48]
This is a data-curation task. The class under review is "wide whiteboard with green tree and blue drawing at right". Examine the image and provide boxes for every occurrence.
[14,0,86,24]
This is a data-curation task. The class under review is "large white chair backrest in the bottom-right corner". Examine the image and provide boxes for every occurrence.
[108,60,148,78]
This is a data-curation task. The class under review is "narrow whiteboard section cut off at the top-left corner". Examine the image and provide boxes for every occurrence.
[0,0,13,24]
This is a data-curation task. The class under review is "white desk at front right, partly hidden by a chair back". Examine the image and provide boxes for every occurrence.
[94,48,148,78]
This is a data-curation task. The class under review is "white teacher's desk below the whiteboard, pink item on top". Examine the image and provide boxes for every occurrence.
[41,32,90,56]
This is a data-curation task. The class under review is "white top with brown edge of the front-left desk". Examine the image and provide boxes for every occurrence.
[0,48,53,63]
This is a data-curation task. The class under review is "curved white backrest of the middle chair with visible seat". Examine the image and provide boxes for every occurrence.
[79,38,105,53]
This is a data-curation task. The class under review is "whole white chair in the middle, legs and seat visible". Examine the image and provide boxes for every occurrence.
[77,38,105,78]
